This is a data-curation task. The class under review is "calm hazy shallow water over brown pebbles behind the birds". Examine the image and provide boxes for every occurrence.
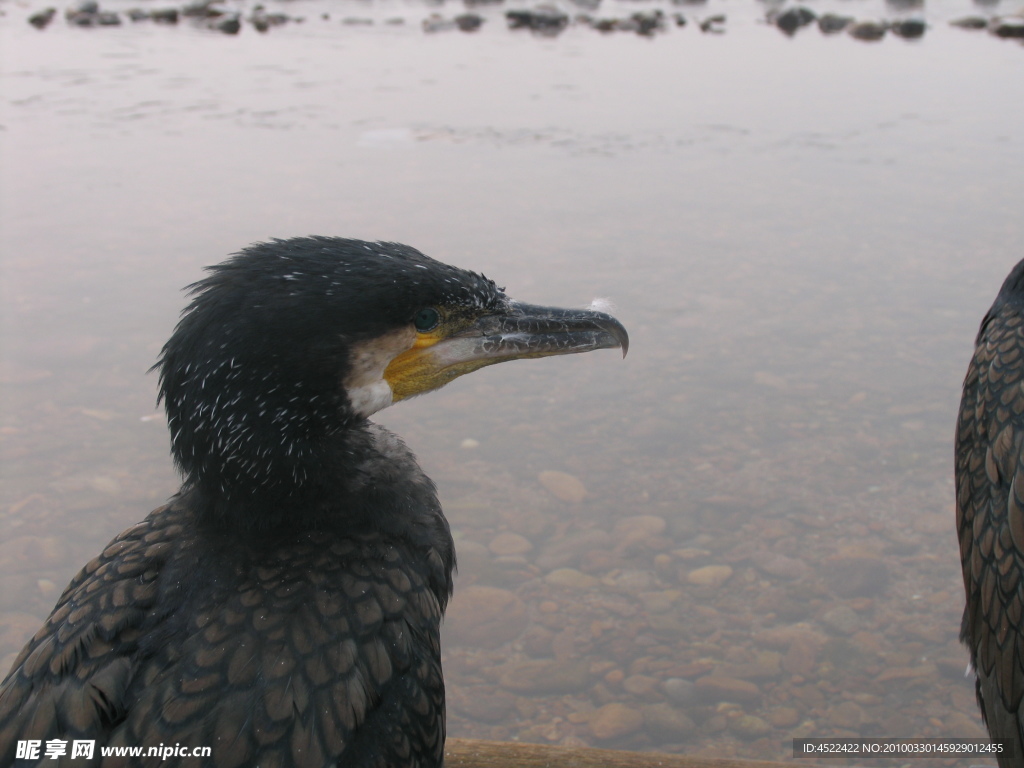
[0,0,1024,765]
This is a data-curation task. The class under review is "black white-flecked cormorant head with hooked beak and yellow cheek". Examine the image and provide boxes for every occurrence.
[155,238,629,512]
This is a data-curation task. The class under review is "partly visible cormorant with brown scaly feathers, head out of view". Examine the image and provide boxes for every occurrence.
[955,261,1024,768]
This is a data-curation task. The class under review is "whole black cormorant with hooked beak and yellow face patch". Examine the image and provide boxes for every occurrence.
[0,238,629,768]
